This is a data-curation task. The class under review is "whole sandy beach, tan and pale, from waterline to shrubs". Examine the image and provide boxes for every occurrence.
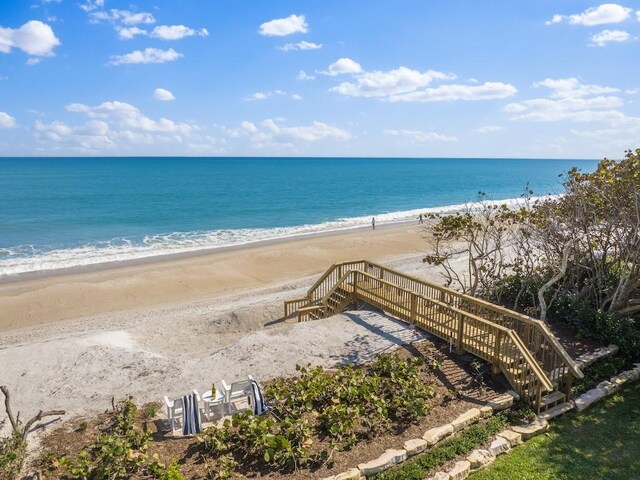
[0,225,452,432]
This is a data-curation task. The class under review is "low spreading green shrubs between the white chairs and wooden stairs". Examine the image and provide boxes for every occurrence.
[200,355,434,478]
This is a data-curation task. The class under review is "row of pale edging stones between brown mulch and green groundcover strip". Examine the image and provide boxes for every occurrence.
[323,392,515,480]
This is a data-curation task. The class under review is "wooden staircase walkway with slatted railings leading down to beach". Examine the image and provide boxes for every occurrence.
[284,260,583,412]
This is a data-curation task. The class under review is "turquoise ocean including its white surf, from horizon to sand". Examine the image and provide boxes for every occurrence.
[0,158,597,275]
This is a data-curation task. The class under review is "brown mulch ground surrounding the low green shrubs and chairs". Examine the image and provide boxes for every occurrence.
[35,340,508,480]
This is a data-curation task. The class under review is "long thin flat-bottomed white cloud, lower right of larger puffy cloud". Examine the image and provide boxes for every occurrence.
[388,82,518,103]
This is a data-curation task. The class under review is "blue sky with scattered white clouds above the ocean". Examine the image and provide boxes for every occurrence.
[0,0,640,159]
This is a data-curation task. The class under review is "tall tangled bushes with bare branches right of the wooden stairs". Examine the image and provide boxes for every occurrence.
[424,149,640,359]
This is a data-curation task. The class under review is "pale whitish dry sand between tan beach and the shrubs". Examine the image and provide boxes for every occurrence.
[0,312,428,430]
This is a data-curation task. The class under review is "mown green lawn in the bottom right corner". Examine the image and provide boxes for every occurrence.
[469,383,640,480]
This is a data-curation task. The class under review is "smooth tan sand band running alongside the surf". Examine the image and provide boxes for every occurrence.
[0,222,426,332]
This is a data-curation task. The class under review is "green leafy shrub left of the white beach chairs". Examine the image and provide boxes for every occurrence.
[49,397,184,480]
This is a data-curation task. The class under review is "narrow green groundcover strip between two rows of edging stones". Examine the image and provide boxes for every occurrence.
[373,413,509,480]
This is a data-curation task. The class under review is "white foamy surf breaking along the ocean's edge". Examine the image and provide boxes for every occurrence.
[0,197,546,277]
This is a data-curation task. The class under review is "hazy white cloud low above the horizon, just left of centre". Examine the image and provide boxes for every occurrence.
[225,118,351,145]
